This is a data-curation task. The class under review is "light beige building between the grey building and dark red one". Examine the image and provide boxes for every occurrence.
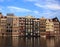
[12,16,19,36]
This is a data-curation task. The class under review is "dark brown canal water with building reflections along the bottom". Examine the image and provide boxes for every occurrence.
[0,37,60,47]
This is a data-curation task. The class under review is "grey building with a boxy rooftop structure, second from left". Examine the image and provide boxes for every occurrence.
[6,13,13,36]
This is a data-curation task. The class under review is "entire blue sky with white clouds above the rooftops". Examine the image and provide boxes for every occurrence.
[0,0,60,19]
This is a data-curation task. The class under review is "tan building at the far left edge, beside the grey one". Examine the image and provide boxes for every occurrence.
[0,13,7,36]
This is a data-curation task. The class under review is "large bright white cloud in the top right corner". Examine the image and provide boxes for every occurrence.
[25,0,60,10]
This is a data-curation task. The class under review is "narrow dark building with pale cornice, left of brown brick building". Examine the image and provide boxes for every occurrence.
[33,18,40,36]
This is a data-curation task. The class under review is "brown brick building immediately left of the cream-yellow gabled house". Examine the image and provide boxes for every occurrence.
[40,17,46,36]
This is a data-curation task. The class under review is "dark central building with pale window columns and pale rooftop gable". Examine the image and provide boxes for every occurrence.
[25,15,35,36]
